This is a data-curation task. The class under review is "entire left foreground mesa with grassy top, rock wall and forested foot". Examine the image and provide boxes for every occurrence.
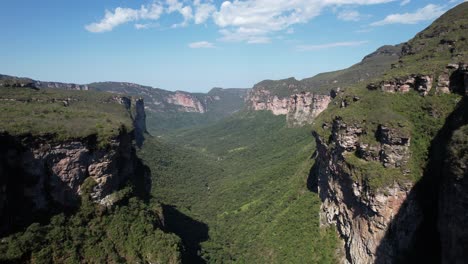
[0,86,181,263]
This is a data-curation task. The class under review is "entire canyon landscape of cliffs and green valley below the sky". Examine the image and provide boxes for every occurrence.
[0,2,468,264]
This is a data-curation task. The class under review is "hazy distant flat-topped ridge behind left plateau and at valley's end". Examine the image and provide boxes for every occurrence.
[0,75,249,131]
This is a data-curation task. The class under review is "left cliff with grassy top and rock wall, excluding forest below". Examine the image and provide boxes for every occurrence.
[0,87,148,233]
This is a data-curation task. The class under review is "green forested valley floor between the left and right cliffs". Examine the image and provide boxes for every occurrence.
[140,112,336,263]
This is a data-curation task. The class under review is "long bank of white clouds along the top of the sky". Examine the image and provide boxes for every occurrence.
[85,0,402,43]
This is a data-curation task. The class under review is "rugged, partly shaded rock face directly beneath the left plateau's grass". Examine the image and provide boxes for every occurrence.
[0,133,136,209]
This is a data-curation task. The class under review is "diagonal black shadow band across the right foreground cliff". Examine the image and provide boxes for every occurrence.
[375,97,468,264]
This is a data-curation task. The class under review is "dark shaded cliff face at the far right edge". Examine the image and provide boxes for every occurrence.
[438,96,468,264]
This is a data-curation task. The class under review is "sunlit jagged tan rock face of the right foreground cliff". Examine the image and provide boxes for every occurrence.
[314,118,422,263]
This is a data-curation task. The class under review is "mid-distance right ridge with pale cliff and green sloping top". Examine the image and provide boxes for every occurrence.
[246,45,402,126]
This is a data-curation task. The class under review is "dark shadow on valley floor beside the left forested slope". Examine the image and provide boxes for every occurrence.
[163,204,209,264]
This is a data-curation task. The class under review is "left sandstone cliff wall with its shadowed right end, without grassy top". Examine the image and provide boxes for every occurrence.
[0,96,150,233]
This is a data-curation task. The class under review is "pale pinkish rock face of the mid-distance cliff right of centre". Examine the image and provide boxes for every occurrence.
[246,89,331,126]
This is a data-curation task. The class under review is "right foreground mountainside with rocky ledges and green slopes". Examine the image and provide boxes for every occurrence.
[314,3,468,263]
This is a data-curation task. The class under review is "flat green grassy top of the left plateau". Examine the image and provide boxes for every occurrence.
[0,88,133,144]
